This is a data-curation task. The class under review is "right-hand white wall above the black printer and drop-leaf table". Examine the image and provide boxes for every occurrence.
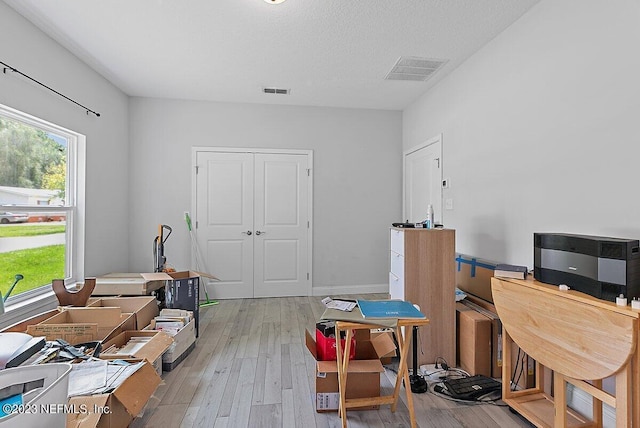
[403,0,640,267]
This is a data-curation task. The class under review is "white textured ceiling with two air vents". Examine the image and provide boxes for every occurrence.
[5,0,538,110]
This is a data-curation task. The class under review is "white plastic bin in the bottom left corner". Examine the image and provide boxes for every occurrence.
[0,363,72,428]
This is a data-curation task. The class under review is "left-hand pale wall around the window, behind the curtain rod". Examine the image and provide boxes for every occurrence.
[0,2,129,276]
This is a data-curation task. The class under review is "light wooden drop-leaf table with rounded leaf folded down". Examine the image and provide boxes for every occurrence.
[491,278,640,427]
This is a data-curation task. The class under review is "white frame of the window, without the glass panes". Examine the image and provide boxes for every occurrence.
[0,104,86,310]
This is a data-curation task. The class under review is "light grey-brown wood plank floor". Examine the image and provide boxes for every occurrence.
[131,295,532,428]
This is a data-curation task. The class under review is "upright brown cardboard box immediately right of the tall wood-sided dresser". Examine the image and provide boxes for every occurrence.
[456,303,492,377]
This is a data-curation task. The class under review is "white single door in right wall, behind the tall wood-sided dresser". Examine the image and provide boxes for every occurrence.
[403,136,442,224]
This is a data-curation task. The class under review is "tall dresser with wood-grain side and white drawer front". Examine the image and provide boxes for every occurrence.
[389,227,456,367]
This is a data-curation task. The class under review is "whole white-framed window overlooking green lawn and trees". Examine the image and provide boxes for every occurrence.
[0,105,84,304]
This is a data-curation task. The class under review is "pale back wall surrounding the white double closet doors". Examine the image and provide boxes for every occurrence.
[129,98,402,295]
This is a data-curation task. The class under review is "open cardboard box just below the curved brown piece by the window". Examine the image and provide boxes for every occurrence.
[27,307,135,345]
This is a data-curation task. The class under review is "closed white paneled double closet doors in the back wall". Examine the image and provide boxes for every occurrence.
[194,148,312,299]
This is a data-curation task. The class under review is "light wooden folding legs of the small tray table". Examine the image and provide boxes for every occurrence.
[336,318,429,428]
